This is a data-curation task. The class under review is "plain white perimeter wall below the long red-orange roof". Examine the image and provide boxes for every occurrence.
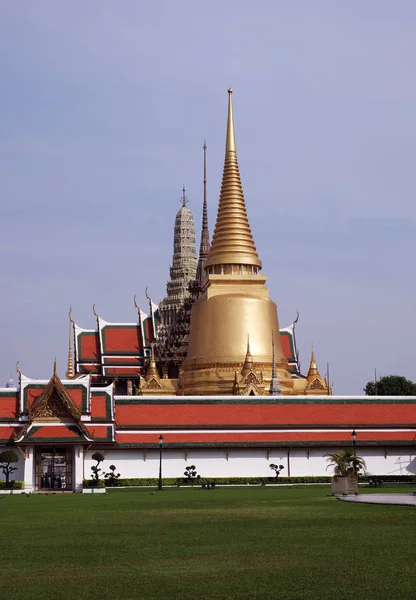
[84,447,416,479]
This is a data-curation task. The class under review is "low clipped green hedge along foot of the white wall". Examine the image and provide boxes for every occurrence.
[83,475,416,487]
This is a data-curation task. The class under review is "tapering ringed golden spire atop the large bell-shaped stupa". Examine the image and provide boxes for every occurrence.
[205,89,261,269]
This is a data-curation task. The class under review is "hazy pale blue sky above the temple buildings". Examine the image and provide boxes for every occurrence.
[0,0,416,394]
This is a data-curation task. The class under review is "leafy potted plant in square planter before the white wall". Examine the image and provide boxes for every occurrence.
[325,448,365,495]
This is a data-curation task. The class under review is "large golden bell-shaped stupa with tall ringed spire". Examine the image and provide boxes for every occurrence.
[183,90,294,395]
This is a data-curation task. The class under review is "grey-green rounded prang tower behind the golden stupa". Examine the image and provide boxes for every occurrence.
[158,186,197,340]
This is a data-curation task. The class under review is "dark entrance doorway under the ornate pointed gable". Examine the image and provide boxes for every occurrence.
[36,447,72,490]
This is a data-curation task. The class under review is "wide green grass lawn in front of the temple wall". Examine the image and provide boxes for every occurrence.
[0,486,416,600]
